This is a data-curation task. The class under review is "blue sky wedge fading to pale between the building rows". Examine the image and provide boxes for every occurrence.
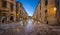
[16,0,39,16]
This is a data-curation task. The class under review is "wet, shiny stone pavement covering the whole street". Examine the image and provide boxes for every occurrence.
[0,19,60,35]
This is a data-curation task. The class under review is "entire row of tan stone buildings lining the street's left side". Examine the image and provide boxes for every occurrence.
[0,0,28,23]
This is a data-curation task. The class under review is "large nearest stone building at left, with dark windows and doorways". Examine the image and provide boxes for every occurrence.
[0,0,16,23]
